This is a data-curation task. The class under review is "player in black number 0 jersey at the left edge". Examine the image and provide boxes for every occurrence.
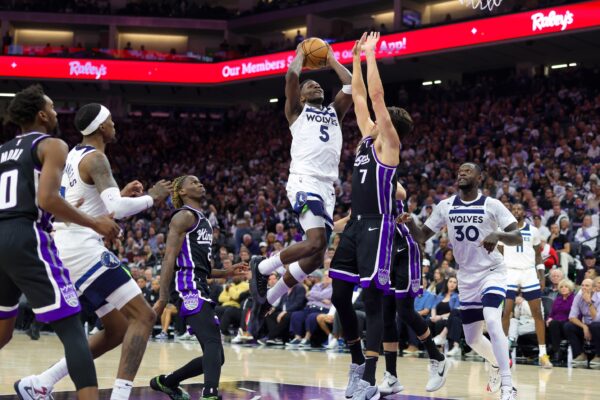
[0,85,119,399]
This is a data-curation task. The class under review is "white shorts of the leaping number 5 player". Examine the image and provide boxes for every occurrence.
[286,174,335,232]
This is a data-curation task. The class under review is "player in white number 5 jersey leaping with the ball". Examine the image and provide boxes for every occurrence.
[250,39,352,328]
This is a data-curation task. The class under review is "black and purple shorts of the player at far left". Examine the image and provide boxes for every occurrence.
[0,218,81,323]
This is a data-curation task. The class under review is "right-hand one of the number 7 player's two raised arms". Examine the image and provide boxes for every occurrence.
[363,32,400,161]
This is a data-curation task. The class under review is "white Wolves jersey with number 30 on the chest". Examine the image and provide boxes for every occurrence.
[425,194,517,273]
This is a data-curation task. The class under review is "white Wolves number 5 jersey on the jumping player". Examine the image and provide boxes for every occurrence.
[290,103,342,182]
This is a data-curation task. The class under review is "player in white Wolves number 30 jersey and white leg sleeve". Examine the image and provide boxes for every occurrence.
[400,163,523,400]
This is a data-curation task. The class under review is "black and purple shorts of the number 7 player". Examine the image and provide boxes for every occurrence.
[329,215,395,293]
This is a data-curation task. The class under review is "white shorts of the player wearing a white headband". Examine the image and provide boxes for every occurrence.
[55,229,142,318]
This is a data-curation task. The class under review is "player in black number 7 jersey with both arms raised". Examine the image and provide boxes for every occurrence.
[329,33,412,400]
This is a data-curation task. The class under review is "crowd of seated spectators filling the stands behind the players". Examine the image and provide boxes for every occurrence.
[0,64,600,365]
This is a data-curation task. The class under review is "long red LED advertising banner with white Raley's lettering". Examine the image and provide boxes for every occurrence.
[0,0,600,84]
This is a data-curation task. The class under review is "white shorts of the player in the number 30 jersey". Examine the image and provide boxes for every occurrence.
[457,264,506,325]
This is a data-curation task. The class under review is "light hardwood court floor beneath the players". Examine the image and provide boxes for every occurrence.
[0,333,600,400]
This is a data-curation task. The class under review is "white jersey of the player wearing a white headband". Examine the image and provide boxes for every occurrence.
[54,145,108,237]
